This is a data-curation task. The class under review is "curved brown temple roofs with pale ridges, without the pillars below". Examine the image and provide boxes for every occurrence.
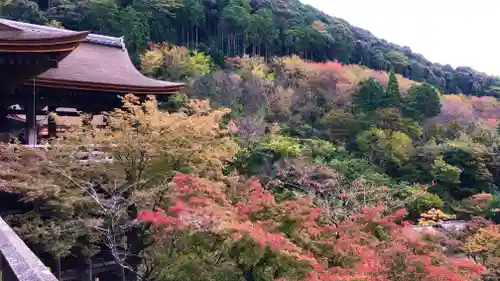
[0,19,184,94]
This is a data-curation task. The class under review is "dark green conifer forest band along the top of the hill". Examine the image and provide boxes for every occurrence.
[0,0,500,96]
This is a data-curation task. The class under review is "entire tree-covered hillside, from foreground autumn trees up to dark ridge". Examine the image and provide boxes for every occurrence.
[0,0,500,281]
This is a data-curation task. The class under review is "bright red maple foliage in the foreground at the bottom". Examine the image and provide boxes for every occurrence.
[139,174,484,281]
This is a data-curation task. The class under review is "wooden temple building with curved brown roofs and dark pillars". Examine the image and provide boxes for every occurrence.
[0,19,184,145]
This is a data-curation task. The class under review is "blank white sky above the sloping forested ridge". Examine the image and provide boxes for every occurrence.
[301,0,500,75]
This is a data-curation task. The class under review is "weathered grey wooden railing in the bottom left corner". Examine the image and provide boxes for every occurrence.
[0,217,57,281]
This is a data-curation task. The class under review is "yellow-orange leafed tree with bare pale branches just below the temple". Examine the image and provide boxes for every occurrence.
[0,95,237,280]
